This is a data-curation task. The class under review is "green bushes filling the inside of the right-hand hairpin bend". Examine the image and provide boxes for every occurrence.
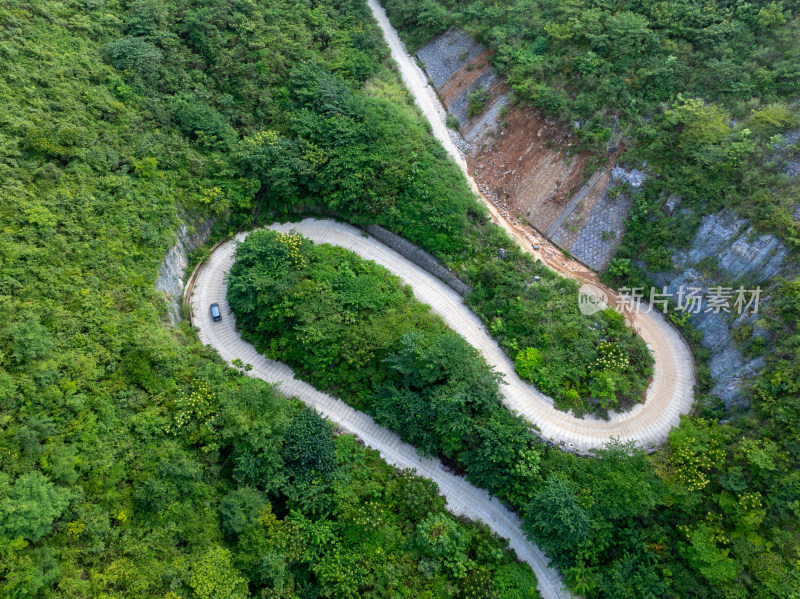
[467,259,653,413]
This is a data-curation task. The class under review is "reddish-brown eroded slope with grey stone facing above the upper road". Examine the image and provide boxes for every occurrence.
[417,30,630,270]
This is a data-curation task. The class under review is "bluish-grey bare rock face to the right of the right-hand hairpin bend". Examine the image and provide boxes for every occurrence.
[653,209,798,409]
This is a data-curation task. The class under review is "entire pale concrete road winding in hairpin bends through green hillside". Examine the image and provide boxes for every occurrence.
[186,5,694,599]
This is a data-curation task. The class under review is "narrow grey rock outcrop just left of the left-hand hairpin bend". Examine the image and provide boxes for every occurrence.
[156,219,213,324]
